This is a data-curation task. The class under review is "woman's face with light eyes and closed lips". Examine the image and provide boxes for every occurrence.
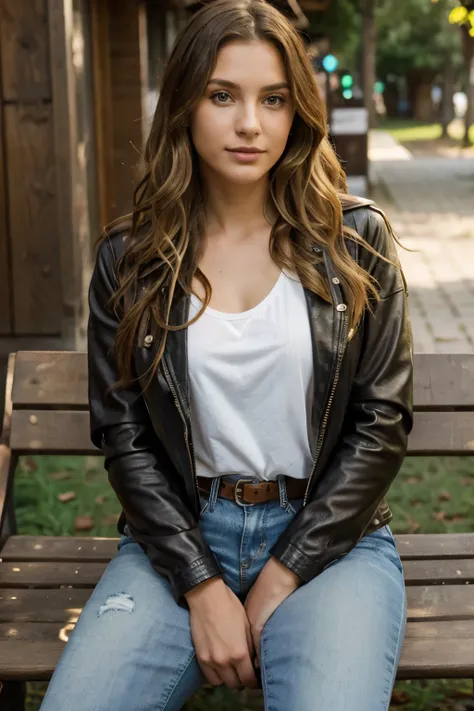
[190,40,294,184]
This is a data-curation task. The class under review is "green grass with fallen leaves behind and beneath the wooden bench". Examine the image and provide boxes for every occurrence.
[15,457,474,711]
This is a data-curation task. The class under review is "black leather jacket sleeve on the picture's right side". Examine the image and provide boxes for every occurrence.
[271,211,413,582]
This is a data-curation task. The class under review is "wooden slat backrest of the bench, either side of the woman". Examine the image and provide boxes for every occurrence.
[4,351,474,455]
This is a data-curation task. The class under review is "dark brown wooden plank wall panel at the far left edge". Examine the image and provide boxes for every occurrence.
[0,0,62,336]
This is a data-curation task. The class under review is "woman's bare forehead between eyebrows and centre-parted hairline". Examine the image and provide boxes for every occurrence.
[211,40,288,87]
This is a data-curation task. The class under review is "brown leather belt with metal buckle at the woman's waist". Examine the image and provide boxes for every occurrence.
[197,476,308,504]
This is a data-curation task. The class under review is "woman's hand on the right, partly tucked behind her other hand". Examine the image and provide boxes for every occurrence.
[245,558,303,666]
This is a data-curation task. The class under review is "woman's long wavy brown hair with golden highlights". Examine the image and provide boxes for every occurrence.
[106,0,377,385]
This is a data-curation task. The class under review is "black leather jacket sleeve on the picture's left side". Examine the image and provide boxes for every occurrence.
[88,240,221,605]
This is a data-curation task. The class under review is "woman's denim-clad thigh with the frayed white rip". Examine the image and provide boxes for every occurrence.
[41,539,204,711]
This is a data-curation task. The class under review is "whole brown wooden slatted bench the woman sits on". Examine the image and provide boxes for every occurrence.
[0,352,474,711]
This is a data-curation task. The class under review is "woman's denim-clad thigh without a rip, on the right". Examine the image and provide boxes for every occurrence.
[261,526,406,711]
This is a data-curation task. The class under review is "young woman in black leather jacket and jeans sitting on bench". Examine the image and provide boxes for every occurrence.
[42,0,412,711]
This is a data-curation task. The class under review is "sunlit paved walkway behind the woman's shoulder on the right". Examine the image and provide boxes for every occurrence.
[369,131,474,353]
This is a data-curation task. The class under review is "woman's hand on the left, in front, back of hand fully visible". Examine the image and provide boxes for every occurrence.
[185,578,257,689]
